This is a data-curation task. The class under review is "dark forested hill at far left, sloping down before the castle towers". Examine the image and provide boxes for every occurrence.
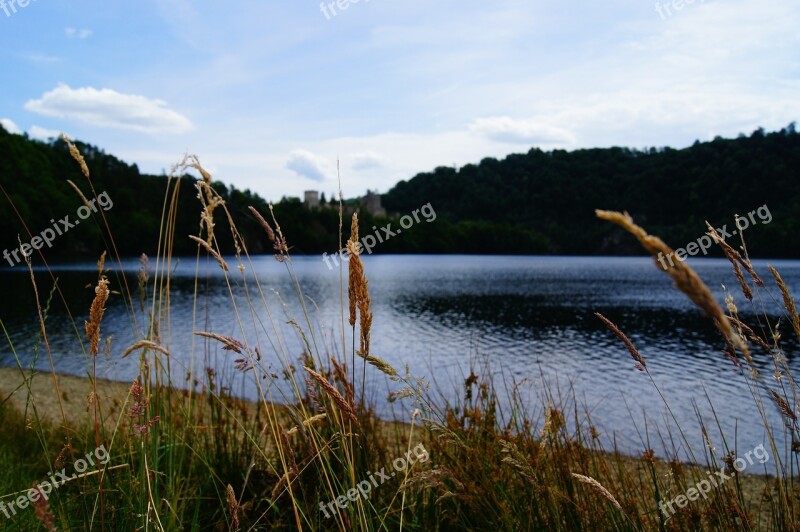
[0,127,278,266]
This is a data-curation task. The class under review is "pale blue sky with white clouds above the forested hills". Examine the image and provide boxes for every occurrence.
[0,0,800,200]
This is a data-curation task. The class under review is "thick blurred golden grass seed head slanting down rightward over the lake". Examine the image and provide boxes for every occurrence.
[595,210,748,354]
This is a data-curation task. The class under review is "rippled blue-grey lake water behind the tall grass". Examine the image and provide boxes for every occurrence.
[0,255,800,462]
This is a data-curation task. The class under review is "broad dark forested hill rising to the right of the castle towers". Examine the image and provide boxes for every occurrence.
[383,124,800,257]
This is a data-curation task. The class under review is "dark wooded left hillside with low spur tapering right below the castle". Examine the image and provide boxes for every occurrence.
[0,126,547,260]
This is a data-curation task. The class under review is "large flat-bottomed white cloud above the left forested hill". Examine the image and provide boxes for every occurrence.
[25,83,193,134]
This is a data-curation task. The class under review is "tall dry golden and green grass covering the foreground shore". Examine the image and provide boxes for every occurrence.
[0,138,800,531]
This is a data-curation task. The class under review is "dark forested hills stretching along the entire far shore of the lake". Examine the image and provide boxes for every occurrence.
[0,122,800,265]
